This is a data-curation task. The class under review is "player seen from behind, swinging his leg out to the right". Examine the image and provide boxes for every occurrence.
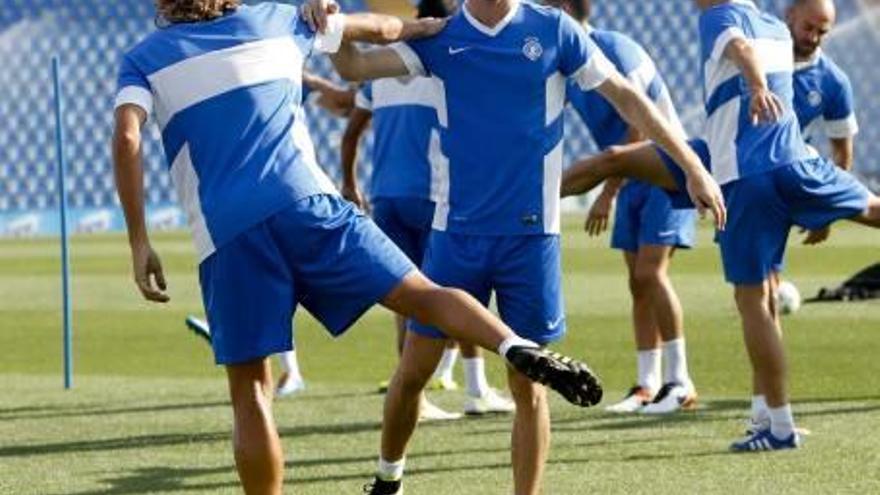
[113,0,601,495]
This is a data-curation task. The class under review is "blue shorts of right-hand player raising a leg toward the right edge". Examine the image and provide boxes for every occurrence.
[717,158,871,285]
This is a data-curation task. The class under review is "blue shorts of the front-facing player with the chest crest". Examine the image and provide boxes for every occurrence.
[411,230,565,345]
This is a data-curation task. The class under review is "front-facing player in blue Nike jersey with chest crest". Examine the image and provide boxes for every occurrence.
[310,0,724,495]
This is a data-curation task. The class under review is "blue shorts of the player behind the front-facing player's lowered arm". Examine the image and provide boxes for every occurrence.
[611,180,697,253]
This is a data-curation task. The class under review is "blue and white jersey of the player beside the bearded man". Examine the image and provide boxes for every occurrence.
[700,0,809,184]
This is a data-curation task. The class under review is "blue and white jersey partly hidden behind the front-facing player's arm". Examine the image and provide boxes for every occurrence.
[567,26,687,150]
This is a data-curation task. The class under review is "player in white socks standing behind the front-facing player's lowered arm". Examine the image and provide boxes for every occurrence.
[552,0,697,414]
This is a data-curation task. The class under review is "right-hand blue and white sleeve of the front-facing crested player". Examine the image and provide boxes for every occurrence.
[559,14,617,91]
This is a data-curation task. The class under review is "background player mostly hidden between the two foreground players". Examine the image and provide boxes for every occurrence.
[341,0,514,419]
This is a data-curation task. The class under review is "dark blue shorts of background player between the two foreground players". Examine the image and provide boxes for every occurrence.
[371,197,434,265]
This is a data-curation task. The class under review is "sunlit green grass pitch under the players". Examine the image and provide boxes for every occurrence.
[0,218,880,495]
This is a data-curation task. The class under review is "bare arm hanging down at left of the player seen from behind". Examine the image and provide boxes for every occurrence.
[113,104,170,303]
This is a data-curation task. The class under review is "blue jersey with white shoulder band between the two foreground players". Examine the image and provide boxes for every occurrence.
[355,77,445,200]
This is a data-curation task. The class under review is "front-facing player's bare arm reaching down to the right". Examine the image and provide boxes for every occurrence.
[597,73,727,229]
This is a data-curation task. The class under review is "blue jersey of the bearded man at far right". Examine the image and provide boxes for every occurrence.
[794,50,859,143]
